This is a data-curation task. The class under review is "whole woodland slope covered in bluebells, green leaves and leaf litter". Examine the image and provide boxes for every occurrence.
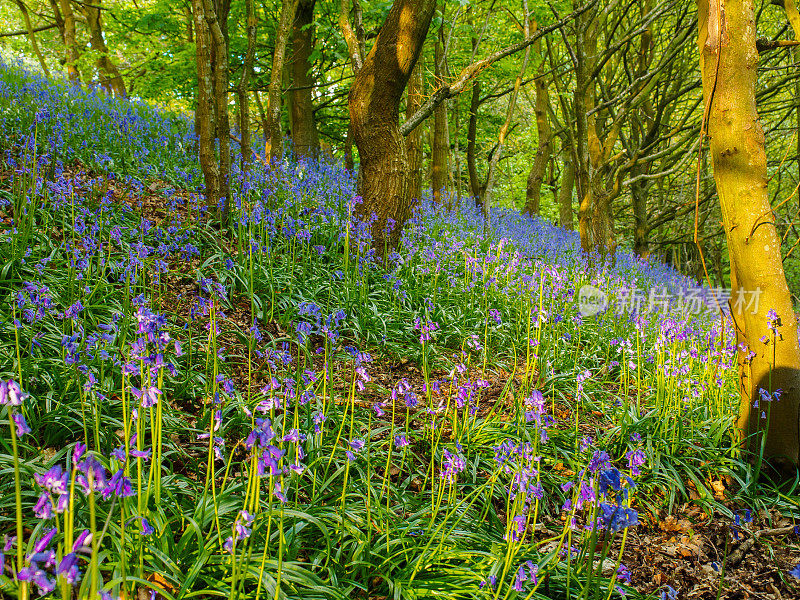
[0,59,800,600]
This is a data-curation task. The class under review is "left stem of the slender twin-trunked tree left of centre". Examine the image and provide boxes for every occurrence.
[192,0,219,216]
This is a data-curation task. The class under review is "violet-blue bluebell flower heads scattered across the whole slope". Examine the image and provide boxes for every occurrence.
[0,59,768,591]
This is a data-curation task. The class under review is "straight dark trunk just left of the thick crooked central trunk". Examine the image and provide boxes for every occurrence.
[292,0,319,157]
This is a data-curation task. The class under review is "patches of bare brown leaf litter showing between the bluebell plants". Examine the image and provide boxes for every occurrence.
[114,166,800,600]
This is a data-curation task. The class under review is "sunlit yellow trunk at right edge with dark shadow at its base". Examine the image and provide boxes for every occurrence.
[698,0,800,470]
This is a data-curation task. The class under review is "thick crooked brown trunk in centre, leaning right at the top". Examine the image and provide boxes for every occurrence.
[348,0,436,257]
